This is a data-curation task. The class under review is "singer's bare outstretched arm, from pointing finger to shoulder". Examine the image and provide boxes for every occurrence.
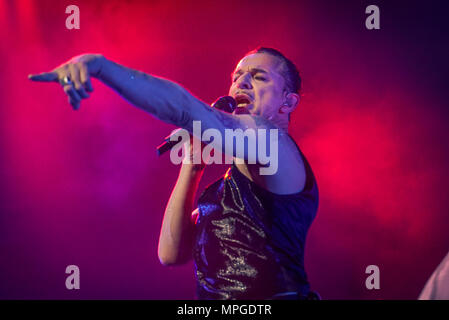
[30,54,305,193]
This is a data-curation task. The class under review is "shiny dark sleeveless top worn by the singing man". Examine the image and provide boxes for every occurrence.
[193,139,318,300]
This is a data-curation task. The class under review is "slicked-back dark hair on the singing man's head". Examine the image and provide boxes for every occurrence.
[246,46,302,121]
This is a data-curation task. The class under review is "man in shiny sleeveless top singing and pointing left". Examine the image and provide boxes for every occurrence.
[30,47,318,299]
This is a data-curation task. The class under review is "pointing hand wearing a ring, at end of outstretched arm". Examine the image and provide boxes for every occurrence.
[28,54,103,110]
